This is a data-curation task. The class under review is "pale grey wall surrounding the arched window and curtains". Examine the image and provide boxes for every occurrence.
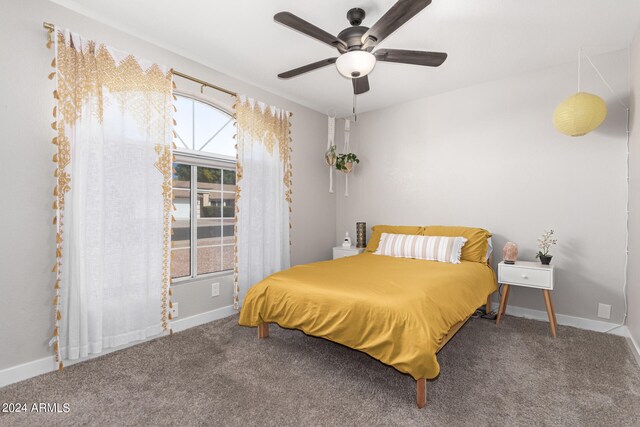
[0,0,335,370]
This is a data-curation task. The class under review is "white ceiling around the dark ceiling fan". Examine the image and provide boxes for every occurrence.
[52,0,640,115]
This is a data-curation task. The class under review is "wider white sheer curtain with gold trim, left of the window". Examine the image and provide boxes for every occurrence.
[52,29,172,359]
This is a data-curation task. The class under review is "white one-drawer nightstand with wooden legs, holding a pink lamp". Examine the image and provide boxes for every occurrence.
[496,261,558,337]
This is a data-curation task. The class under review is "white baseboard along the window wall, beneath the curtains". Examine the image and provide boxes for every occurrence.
[0,305,236,387]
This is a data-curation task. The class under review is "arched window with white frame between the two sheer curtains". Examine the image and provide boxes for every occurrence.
[171,95,236,281]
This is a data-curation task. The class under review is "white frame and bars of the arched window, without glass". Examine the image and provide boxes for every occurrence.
[171,90,237,285]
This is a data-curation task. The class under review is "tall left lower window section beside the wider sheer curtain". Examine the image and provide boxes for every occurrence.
[171,163,191,278]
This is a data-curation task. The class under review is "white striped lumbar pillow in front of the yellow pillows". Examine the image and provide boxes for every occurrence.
[374,233,467,264]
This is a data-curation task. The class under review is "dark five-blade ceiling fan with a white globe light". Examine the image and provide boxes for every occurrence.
[273,0,447,95]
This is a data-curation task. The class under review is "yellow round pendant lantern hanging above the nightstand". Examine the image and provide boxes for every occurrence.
[553,92,607,136]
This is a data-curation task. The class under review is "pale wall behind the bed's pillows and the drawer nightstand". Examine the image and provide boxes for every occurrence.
[336,50,629,322]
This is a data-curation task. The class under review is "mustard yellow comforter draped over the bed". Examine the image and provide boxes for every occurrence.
[240,253,496,379]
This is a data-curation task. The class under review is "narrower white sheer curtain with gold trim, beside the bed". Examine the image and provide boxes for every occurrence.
[234,96,291,308]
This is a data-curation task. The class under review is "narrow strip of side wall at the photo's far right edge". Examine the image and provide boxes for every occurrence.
[627,26,640,344]
